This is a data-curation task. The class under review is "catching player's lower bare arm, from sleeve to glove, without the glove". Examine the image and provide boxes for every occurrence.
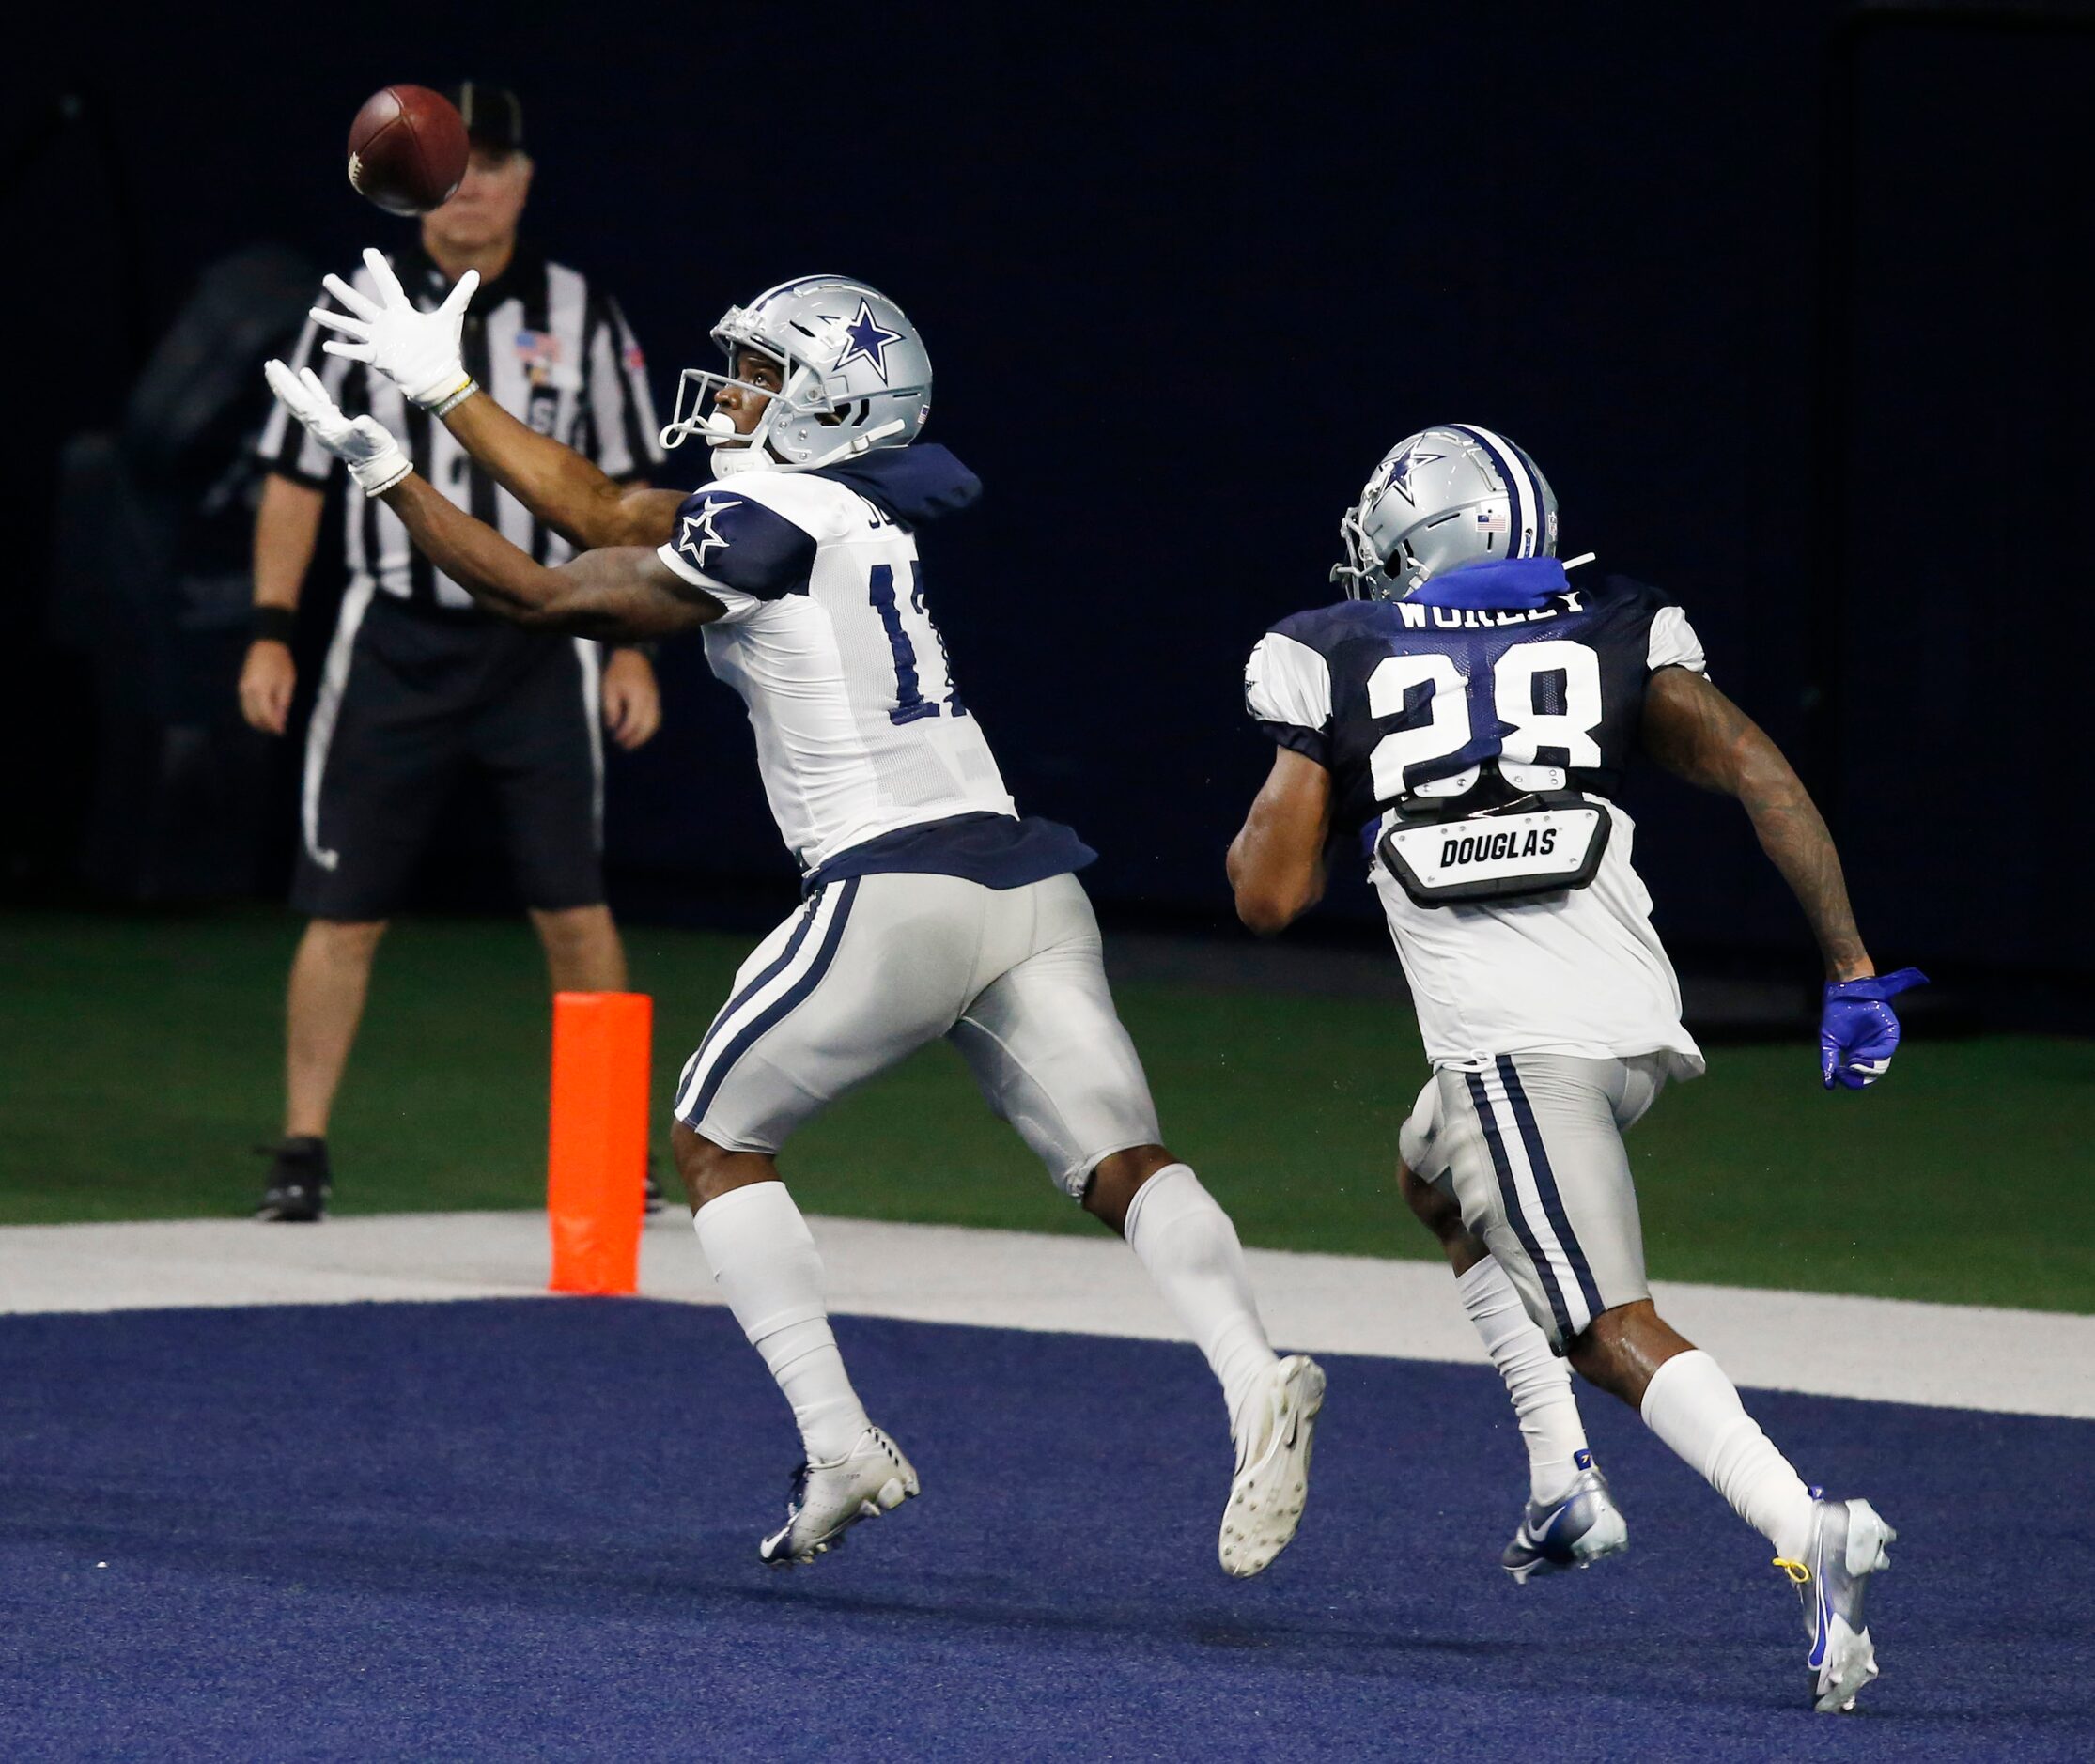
[380,472,725,642]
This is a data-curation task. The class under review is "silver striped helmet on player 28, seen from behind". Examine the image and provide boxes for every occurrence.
[1330,424,1557,601]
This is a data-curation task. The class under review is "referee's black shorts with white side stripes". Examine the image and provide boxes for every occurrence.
[291,591,603,920]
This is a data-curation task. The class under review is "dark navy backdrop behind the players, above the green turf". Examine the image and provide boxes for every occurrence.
[0,0,2095,1022]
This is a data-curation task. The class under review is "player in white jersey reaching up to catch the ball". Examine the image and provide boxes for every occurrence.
[268,254,1324,1575]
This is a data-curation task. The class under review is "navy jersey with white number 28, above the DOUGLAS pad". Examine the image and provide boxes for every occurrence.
[1245,576,1703,828]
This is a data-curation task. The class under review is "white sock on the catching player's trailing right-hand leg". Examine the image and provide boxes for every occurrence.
[1125,1163,1276,1435]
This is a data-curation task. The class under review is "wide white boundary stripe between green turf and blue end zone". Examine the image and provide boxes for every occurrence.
[0,1207,2095,1420]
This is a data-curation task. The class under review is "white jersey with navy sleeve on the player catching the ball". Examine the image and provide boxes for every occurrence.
[658,446,1016,870]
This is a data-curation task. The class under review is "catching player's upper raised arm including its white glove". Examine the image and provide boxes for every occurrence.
[312,252,683,551]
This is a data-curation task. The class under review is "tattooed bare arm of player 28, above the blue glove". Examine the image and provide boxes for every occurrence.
[1642,668,1877,981]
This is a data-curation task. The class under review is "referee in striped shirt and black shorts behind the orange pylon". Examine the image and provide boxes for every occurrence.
[241,82,662,1219]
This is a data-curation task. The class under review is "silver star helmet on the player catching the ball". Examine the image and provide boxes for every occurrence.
[662,276,930,472]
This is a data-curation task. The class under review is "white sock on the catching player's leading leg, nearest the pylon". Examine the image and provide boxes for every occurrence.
[691,1182,867,1464]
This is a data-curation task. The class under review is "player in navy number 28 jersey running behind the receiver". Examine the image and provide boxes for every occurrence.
[1230,424,1923,1710]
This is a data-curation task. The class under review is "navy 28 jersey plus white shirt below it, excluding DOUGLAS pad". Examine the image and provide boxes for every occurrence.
[1245,576,1703,1076]
